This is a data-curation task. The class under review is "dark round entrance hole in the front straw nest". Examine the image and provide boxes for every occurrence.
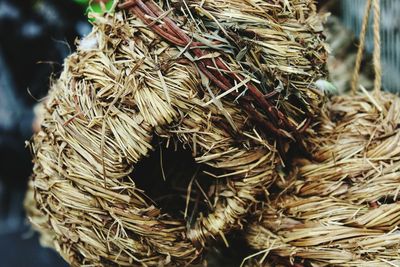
[130,138,220,225]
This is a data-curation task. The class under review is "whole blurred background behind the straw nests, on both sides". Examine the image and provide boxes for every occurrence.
[0,0,400,267]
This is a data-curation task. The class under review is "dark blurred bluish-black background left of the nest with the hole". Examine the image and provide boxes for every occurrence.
[0,0,91,267]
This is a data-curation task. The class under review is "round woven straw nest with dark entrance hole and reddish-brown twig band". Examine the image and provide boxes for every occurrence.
[27,0,326,266]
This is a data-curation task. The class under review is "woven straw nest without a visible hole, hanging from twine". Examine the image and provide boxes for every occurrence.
[246,91,400,266]
